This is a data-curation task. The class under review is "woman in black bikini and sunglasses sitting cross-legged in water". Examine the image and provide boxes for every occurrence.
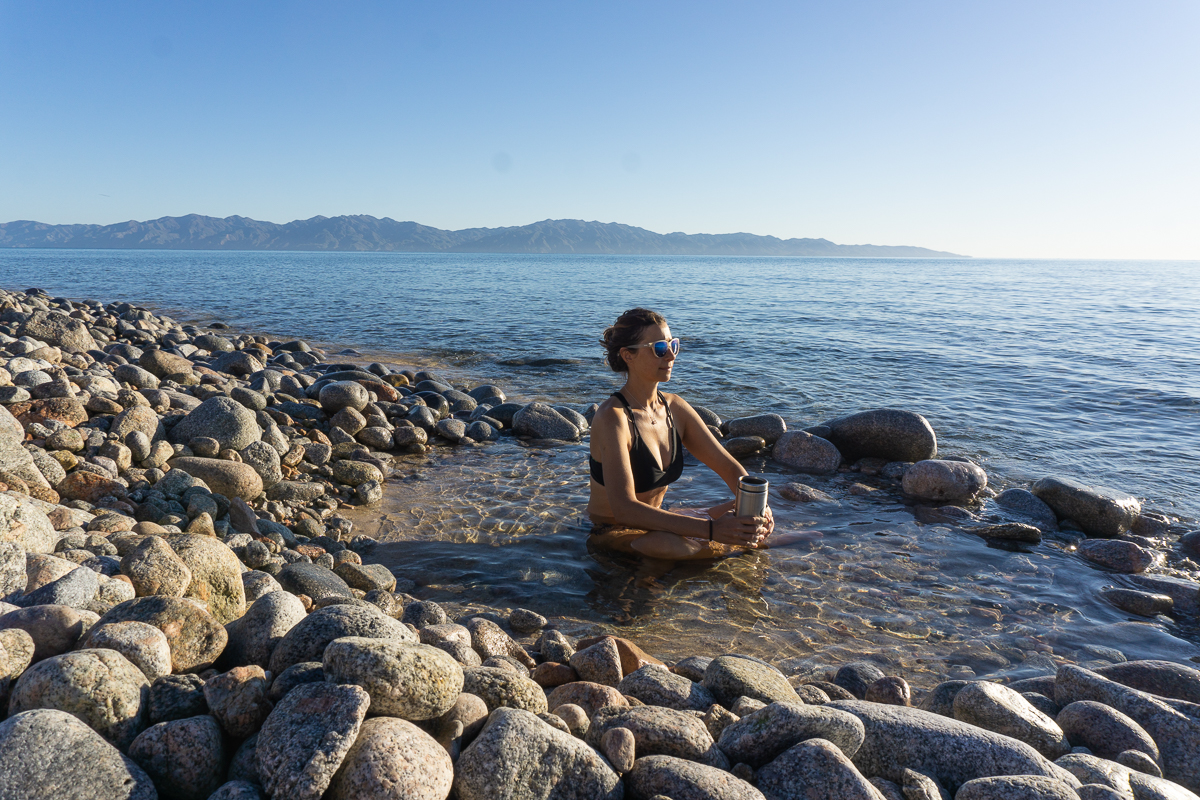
[588,308,775,560]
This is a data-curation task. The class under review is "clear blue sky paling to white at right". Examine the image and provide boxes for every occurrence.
[0,0,1200,259]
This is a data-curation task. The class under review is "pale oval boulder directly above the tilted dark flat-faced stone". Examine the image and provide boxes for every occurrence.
[323,637,463,721]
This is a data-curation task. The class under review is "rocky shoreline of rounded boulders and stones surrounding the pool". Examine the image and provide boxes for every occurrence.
[0,290,1200,800]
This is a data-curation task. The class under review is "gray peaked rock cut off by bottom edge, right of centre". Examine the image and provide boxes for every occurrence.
[756,738,883,800]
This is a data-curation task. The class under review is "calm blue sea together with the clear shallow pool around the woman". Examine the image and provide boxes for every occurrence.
[0,249,1200,682]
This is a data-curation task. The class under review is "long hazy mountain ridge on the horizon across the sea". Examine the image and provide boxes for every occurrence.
[0,213,961,258]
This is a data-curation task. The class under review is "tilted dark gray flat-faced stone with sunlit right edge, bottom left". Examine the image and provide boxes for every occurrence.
[256,684,371,800]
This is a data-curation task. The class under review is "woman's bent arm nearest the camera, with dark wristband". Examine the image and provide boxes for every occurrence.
[592,408,756,545]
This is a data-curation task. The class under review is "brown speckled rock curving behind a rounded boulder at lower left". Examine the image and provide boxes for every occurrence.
[91,596,228,672]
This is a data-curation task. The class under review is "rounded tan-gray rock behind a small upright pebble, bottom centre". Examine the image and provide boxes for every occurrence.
[587,705,730,771]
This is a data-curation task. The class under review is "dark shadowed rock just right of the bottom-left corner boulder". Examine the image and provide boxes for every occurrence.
[130,715,228,800]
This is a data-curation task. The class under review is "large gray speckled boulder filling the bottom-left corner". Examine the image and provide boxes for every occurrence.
[0,709,158,800]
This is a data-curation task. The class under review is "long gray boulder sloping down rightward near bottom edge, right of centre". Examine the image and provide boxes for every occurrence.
[824,700,1062,792]
